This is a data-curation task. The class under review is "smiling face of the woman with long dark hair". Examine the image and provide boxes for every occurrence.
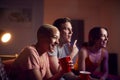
[96,28,108,47]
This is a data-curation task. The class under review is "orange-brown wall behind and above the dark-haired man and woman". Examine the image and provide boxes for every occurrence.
[44,0,120,74]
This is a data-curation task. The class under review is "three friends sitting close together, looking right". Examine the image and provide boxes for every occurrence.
[1,17,108,80]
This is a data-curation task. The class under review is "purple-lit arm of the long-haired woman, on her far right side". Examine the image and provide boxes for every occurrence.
[100,50,108,80]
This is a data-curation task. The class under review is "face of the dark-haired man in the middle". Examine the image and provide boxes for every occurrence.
[60,22,73,44]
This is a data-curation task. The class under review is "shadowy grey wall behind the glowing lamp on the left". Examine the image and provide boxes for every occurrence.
[0,0,43,54]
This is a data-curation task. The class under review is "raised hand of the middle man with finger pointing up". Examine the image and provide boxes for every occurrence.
[69,40,78,59]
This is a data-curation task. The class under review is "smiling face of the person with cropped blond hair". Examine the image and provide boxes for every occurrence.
[49,29,60,52]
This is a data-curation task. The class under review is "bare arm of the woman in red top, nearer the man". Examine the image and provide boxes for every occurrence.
[78,48,87,71]
